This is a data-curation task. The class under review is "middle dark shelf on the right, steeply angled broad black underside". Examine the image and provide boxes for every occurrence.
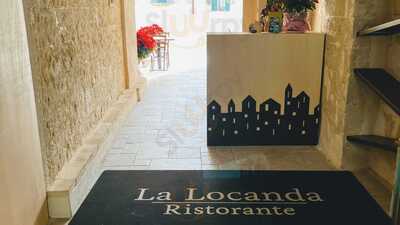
[354,69,400,115]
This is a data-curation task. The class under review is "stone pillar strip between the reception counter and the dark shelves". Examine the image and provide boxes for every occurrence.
[319,0,355,168]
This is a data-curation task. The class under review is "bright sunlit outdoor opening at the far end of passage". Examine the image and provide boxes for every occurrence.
[136,0,243,72]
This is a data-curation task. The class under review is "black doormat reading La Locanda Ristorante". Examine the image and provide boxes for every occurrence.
[70,171,392,225]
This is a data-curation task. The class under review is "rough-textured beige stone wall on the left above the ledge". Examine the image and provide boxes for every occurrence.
[24,0,125,183]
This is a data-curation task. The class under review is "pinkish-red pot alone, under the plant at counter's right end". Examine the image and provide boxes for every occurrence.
[283,12,311,33]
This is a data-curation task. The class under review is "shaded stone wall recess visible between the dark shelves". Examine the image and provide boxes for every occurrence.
[343,0,400,184]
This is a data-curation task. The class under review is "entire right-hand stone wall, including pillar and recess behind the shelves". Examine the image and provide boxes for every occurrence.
[319,0,400,186]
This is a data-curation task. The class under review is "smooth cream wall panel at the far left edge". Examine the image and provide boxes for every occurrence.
[0,0,47,225]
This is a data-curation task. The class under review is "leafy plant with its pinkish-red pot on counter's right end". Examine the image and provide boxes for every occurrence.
[282,0,318,32]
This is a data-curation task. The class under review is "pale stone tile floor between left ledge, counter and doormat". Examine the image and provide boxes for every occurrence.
[104,69,332,170]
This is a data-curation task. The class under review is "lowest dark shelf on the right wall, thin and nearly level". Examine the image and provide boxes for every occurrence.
[347,135,399,152]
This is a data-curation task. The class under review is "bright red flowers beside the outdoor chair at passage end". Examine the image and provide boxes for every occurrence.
[136,24,164,60]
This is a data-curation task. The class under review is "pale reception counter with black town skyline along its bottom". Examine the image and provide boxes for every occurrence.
[207,33,325,146]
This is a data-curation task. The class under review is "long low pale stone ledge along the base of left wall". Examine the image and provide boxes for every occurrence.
[47,88,138,219]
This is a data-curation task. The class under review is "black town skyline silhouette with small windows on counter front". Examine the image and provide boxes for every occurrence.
[207,84,321,146]
